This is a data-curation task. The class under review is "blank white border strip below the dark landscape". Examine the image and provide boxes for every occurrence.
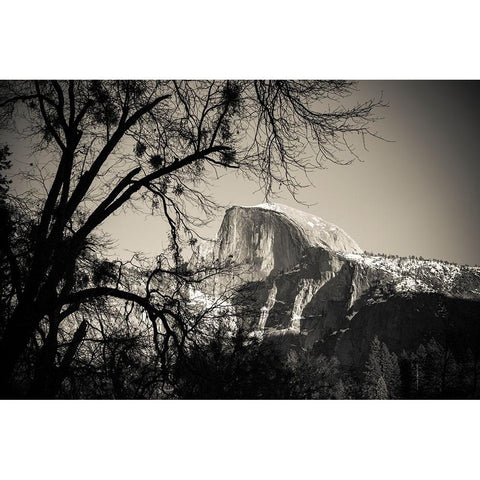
[0,400,480,480]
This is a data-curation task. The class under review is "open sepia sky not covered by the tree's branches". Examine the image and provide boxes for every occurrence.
[104,80,480,265]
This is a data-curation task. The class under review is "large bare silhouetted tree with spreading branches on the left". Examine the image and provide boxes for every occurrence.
[0,80,382,396]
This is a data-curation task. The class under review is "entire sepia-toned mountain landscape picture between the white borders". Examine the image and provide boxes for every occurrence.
[0,80,480,400]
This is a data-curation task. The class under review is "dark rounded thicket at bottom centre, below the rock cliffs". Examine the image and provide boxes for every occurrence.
[173,330,345,399]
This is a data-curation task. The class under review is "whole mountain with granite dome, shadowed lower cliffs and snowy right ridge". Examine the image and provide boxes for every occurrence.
[191,204,480,367]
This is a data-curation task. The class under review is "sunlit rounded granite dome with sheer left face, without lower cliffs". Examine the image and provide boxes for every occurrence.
[199,204,362,281]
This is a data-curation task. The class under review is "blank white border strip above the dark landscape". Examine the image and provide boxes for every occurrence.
[0,0,479,79]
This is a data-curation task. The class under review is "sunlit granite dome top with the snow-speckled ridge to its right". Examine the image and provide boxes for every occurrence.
[192,203,480,298]
